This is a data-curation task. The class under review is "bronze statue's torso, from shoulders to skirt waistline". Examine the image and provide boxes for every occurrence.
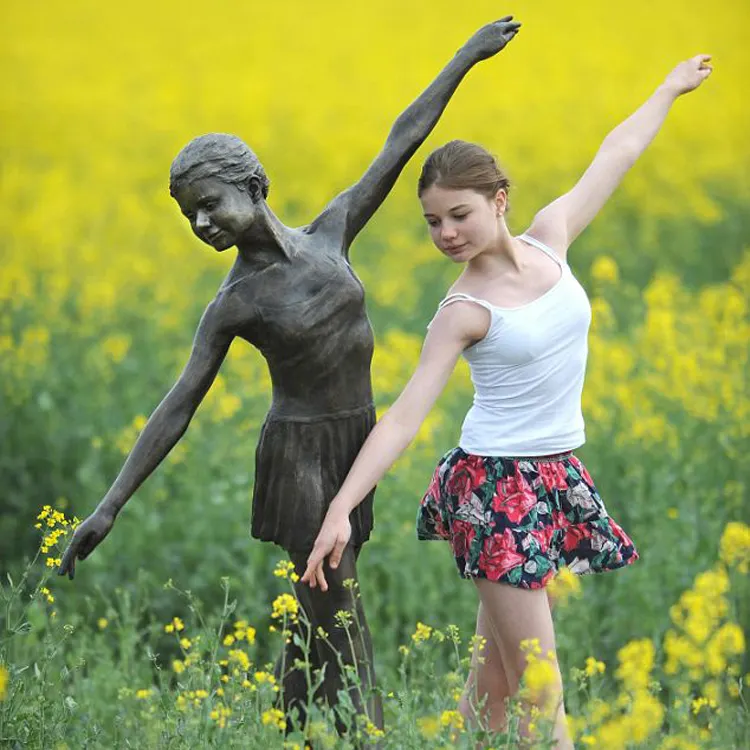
[231,235,373,418]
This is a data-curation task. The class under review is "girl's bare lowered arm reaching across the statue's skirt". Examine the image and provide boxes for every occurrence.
[302,302,489,591]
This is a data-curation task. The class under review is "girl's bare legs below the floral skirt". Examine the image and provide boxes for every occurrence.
[472,579,573,750]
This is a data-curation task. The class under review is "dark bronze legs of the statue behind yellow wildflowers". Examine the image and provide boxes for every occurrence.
[291,546,383,732]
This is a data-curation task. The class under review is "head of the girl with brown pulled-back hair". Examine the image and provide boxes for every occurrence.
[417,141,510,261]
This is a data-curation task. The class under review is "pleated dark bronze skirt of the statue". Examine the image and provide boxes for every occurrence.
[251,405,375,552]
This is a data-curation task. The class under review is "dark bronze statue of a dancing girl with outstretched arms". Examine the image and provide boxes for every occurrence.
[59,16,520,740]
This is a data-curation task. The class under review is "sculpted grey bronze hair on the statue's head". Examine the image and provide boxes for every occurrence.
[169,133,270,198]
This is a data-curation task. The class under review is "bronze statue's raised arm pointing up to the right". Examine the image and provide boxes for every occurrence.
[319,16,521,249]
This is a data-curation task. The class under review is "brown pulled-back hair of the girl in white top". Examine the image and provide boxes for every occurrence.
[417,140,510,207]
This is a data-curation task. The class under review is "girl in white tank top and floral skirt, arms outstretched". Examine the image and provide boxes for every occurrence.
[302,55,711,748]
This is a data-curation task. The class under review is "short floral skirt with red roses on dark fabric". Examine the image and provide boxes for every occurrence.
[417,448,638,589]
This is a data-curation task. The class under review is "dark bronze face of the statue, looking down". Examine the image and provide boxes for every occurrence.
[175,177,258,252]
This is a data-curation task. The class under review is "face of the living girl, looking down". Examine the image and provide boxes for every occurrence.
[420,185,506,263]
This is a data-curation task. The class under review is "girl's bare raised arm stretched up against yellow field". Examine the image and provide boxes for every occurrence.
[528,55,711,256]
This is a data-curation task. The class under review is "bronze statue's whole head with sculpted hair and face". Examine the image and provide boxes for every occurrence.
[169,133,269,251]
